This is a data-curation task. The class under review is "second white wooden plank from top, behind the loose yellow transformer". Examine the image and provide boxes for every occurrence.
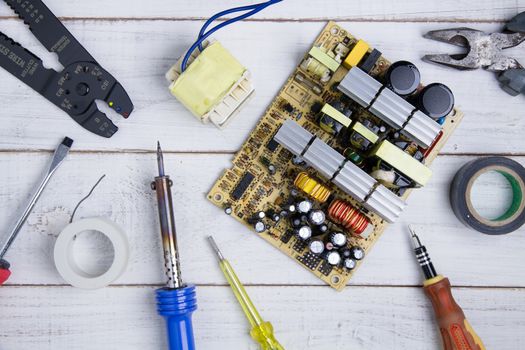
[0,20,525,154]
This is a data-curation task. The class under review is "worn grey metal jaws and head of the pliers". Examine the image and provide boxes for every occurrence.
[423,27,525,72]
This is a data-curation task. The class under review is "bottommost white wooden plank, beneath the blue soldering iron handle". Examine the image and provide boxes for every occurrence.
[0,284,525,350]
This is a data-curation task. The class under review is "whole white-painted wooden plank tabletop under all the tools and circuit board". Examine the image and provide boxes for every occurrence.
[0,0,525,350]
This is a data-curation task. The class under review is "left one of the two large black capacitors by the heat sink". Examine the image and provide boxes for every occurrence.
[385,61,421,96]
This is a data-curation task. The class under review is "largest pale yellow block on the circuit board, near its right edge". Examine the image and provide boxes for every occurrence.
[371,140,432,186]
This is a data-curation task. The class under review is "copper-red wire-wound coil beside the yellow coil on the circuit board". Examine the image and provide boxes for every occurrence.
[328,199,374,238]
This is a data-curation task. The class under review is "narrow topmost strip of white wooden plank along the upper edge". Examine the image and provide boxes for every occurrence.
[0,0,525,22]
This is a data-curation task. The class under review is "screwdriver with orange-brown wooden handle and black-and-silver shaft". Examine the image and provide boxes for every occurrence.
[408,225,485,350]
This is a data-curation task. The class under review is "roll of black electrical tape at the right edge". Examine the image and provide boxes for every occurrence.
[450,157,525,235]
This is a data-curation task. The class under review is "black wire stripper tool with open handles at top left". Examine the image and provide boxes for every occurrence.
[0,0,133,137]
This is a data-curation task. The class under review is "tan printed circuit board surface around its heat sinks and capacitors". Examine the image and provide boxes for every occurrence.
[208,22,463,290]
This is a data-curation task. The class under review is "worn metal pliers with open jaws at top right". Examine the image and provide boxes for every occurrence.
[423,12,525,96]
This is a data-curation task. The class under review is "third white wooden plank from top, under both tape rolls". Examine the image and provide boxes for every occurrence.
[0,152,525,287]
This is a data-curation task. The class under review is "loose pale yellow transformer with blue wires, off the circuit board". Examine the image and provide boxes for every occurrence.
[166,41,254,127]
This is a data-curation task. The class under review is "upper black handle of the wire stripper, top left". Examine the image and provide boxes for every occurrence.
[4,0,96,66]
